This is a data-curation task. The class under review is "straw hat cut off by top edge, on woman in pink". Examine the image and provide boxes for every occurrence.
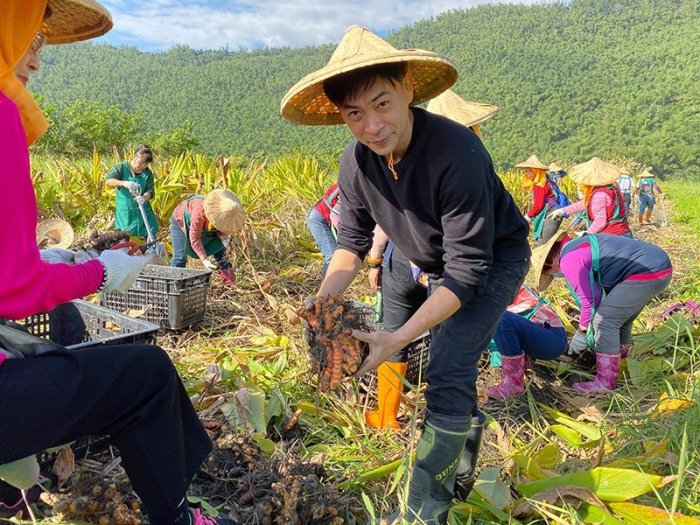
[40,0,112,44]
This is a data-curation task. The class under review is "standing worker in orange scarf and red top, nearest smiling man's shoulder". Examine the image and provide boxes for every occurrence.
[515,155,568,245]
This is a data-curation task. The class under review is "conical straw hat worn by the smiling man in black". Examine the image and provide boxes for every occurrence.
[280,26,457,126]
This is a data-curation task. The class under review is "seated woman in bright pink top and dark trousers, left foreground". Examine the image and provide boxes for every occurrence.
[0,0,235,525]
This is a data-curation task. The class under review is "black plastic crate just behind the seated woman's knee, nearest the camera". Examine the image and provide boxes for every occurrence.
[16,300,158,349]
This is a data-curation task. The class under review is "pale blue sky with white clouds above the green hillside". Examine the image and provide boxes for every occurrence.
[94,0,530,50]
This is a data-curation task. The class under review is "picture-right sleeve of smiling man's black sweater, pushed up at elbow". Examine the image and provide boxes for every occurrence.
[440,148,497,304]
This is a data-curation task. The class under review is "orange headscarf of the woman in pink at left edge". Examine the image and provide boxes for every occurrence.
[0,0,49,145]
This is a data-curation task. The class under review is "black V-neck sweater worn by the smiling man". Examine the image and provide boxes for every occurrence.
[338,108,530,303]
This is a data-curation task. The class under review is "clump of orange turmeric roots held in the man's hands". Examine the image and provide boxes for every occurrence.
[299,297,368,391]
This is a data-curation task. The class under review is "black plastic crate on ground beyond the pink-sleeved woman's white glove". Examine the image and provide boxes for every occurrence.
[100,264,211,330]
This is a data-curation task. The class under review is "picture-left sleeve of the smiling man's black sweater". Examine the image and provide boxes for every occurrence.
[338,141,376,259]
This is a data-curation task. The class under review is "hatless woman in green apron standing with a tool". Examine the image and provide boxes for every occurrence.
[105,146,158,239]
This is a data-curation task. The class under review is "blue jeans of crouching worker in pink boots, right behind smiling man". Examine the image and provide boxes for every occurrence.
[494,311,567,359]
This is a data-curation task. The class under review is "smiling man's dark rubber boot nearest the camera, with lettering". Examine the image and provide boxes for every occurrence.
[406,413,470,525]
